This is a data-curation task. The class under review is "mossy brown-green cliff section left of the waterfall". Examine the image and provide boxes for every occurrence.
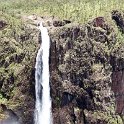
[0,19,39,124]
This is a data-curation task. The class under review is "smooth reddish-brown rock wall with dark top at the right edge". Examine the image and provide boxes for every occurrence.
[110,43,124,115]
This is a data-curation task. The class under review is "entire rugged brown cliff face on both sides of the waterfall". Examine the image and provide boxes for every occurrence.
[0,11,124,124]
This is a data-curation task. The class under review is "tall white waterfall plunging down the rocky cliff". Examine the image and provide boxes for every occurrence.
[35,23,52,124]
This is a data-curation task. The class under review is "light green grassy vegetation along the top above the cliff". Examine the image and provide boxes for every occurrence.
[0,0,124,22]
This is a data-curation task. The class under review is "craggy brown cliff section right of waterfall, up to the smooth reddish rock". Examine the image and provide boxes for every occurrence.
[50,17,123,124]
